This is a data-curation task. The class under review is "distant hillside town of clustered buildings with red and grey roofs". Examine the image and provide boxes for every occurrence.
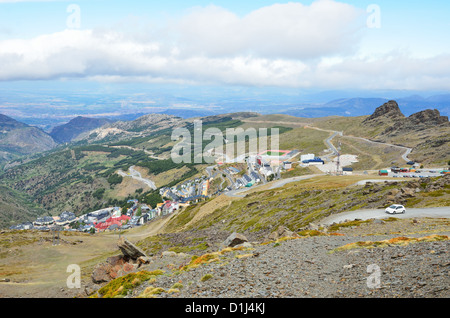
[10,150,450,234]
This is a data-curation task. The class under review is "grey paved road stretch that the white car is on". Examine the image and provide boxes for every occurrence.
[320,207,450,225]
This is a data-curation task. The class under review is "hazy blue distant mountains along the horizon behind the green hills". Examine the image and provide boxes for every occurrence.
[0,94,450,168]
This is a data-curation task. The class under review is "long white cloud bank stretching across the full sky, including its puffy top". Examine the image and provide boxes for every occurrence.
[0,0,450,89]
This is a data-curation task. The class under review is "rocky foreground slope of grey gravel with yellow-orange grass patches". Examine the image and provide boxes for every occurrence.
[91,219,450,298]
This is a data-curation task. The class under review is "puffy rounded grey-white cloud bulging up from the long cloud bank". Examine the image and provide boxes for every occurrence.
[174,0,363,59]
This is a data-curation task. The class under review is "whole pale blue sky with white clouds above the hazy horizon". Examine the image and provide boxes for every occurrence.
[0,0,450,91]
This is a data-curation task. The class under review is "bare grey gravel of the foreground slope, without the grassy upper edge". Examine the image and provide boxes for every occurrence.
[132,227,450,298]
